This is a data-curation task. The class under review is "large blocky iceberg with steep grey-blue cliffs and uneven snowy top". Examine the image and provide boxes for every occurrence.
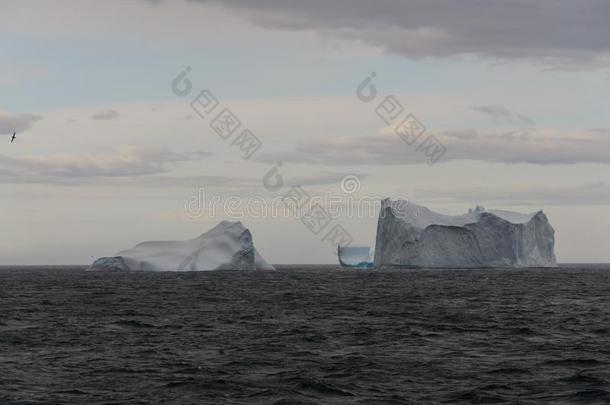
[375,199,557,267]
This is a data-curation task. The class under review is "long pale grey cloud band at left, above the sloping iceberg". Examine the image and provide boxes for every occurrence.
[0,146,356,193]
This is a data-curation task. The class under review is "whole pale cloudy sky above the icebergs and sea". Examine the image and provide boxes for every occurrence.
[0,0,610,265]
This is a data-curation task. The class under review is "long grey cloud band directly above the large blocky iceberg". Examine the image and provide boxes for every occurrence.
[259,129,610,166]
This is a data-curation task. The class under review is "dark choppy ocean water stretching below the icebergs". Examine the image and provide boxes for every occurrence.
[0,266,610,405]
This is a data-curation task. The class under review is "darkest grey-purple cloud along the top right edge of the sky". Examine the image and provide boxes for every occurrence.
[185,0,610,64]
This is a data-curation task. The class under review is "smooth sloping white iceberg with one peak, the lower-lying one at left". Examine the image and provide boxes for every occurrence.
[89,221,274,271]
